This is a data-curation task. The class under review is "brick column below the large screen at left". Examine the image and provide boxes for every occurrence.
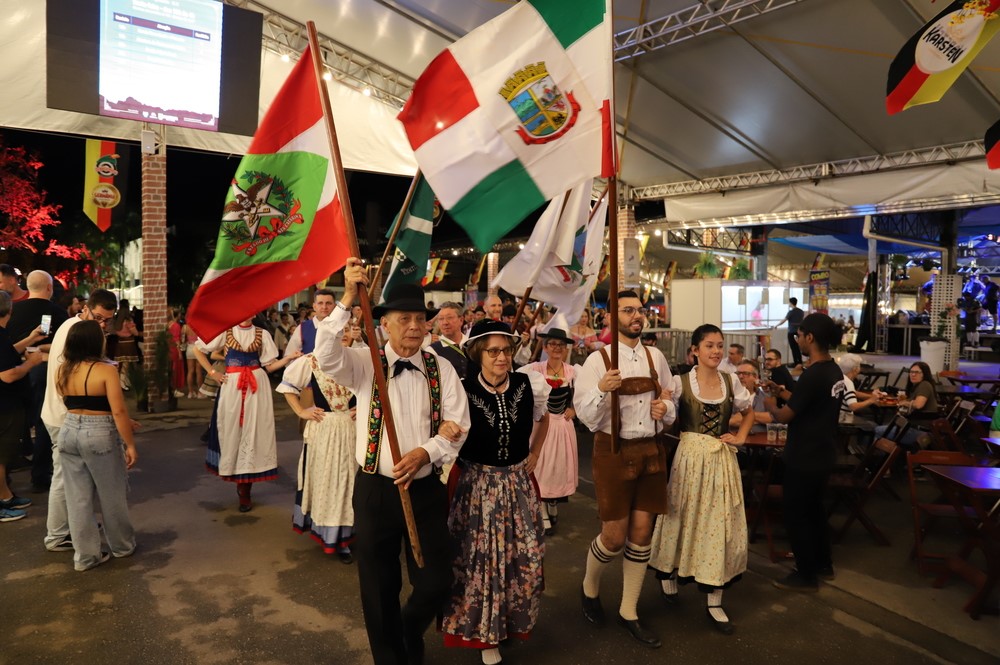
[142,154,170,403]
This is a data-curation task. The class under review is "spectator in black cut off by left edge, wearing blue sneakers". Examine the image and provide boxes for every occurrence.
[0,291,46,522]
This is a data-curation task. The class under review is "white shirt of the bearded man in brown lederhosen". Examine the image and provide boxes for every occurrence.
[573,342,677,439]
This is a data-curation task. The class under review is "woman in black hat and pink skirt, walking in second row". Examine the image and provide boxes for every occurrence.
[525,328,580,535]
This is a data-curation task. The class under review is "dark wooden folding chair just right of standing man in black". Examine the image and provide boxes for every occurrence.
[828,437,900,545]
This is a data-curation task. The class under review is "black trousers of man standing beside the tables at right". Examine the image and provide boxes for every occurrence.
[782,467,833,580]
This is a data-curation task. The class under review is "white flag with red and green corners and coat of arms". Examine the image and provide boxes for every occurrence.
[399,0,614,252]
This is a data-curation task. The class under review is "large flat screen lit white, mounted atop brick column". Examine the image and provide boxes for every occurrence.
[46,0,263,136]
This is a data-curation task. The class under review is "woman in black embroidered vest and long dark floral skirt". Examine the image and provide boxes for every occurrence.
[442,319,549,665]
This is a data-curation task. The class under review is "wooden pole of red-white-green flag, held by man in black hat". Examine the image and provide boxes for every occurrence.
[306,21,424,568]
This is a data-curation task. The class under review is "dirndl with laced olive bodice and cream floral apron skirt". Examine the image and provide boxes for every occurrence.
[649,370,753,591]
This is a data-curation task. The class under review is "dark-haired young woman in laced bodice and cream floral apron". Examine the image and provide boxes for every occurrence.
[649,323,754,635]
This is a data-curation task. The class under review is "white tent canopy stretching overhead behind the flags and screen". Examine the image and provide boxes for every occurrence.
[0,0,1000,223]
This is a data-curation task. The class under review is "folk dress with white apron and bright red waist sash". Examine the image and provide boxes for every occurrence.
[200,325,278,483]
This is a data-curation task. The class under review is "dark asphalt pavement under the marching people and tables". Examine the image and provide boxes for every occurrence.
[0,396,1000,665]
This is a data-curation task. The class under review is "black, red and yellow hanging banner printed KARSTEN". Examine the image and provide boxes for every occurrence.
[885,0,1000,115]
